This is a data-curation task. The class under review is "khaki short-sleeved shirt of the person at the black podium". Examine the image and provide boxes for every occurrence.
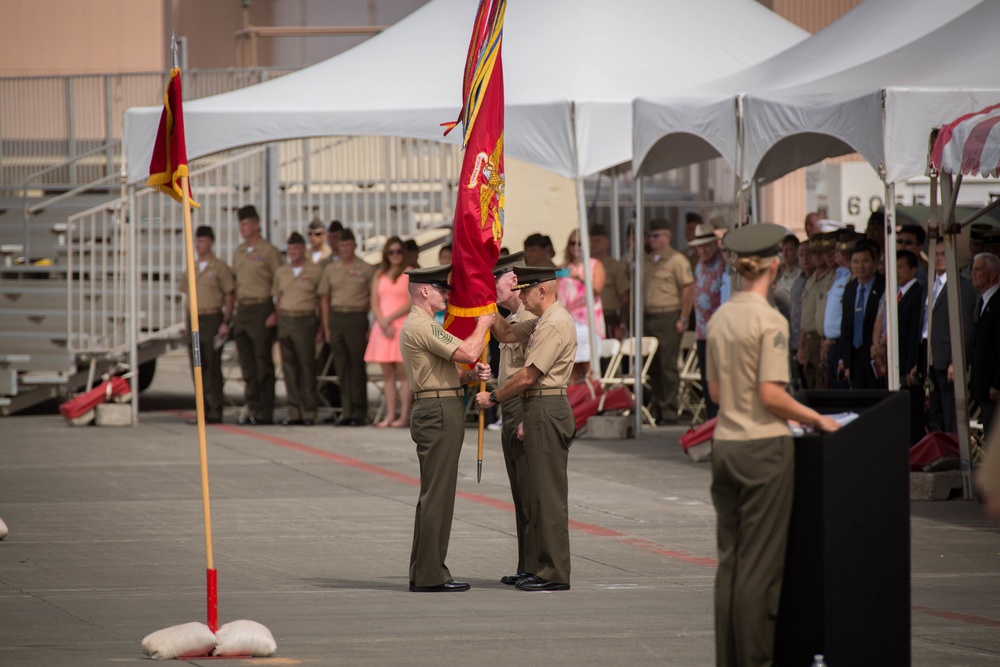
[707,292,791,441]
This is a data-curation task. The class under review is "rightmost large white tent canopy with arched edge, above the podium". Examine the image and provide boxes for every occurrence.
[742,1,1000,188]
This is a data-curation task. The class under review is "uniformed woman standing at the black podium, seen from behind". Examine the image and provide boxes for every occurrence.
[708,224,837,667]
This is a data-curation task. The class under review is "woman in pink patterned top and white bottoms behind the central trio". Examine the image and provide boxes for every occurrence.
[556,231,605,383]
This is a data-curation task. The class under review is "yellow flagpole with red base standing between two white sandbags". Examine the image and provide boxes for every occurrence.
[181,176,218,632]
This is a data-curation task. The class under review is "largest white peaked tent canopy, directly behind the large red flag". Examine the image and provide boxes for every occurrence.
[124,0,806,183]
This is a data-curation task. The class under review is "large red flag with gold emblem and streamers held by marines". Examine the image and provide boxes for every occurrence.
[444,0,507,339]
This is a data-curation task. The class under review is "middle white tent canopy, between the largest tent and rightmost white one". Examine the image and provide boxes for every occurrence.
[633,0,982,174]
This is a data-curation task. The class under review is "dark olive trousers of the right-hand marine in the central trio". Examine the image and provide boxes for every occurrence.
[520,396,576,584]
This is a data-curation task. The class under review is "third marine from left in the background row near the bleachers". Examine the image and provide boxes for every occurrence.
[272,232,323,426]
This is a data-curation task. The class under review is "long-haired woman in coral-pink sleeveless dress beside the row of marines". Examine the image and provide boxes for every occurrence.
[365,236,413,428]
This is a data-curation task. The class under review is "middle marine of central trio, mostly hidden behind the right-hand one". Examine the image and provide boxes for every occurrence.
[493,252,538,586]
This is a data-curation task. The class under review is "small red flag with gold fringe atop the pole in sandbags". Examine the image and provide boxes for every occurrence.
[146,67,200,207]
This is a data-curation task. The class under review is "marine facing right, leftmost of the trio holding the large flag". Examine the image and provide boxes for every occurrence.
[399,265,496,593]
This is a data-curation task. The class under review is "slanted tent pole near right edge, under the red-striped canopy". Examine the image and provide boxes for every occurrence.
[940,174,973,498]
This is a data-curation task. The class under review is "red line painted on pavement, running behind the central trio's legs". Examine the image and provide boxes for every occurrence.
[201,424,718,567]
